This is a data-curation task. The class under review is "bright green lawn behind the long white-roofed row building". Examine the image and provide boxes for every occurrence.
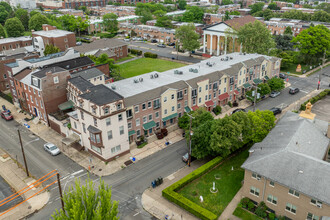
[119,58,185,78]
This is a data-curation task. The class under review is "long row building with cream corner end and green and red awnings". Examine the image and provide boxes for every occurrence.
[67,53,280,161]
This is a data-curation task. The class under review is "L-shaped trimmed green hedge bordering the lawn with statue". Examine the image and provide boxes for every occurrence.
[162,157,222,220]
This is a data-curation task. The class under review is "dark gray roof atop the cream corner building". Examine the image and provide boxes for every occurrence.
[79,84,123,105]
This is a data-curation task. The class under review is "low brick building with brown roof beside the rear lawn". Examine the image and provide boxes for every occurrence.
[74,38,128,60]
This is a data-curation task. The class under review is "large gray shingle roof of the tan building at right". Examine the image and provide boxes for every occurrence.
[242,112,330,204]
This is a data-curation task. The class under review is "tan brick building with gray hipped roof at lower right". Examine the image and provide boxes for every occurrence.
[242,111,330,220]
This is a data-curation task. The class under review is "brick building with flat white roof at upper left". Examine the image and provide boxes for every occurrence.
[32,24,76,51]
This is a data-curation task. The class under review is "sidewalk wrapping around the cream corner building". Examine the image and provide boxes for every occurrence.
[0,98,184,176]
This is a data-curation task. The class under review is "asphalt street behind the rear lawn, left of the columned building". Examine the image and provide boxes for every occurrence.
[128,41,201,63]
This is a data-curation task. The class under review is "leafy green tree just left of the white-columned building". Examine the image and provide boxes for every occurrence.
[175,24,200,56]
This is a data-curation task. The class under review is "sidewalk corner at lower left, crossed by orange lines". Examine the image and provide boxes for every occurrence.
[0,146,49,220]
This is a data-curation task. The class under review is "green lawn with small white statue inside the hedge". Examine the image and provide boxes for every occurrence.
[179,149,249,216]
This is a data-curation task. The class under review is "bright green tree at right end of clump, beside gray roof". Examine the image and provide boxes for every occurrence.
[248,110,275,143]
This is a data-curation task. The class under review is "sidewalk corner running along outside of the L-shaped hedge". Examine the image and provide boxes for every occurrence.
[141,160,203,220]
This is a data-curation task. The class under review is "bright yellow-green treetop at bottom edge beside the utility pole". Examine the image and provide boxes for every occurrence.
[52,178,119,220]
